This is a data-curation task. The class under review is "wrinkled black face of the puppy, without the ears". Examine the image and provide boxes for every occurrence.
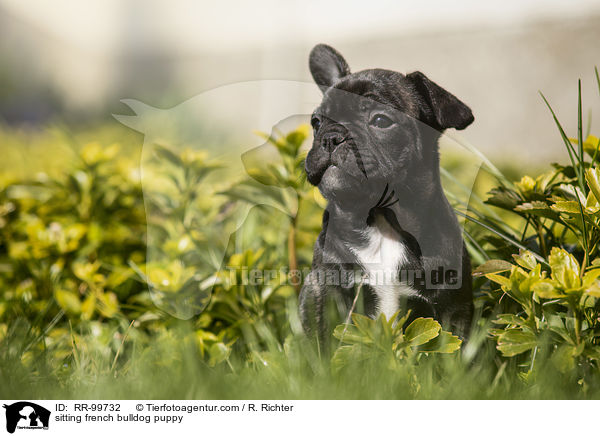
[306,70,423,200]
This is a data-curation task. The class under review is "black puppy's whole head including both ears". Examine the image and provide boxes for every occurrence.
[305,44,473,206]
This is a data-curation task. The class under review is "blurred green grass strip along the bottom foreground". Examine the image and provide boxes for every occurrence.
[1,308,599,399]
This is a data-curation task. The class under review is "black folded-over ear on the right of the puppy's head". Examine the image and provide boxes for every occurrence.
[406,71,475,131]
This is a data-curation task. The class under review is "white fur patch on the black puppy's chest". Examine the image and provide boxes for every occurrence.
[352,217,418,319]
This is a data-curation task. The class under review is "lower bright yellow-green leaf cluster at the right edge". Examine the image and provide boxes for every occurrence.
[486,247,600,371]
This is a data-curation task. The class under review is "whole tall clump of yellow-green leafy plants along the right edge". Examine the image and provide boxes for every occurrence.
[474,67,600,380]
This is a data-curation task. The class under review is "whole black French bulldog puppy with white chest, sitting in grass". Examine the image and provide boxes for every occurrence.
[300,44,473,341]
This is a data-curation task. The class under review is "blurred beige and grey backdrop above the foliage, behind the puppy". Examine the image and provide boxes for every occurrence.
[0,0,600,163]
